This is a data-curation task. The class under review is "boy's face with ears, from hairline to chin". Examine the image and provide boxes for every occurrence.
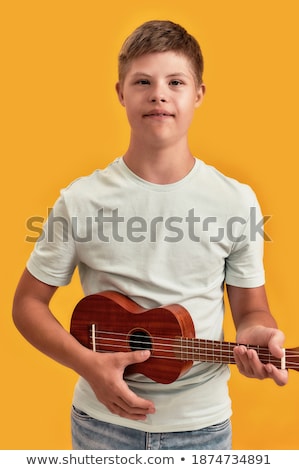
[116,51,205,146]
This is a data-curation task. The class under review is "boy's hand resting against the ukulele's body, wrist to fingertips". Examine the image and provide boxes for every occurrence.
[81,350,155,420]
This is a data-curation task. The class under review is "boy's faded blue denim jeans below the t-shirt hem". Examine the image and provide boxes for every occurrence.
[72,407,232,450]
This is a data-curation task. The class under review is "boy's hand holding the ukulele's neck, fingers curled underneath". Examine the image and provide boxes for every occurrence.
[234,326,288,386]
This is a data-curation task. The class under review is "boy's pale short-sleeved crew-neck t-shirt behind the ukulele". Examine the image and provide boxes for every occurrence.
[27,158,264,432]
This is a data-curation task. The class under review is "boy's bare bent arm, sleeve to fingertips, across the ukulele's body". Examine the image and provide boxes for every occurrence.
[13,270,154,420]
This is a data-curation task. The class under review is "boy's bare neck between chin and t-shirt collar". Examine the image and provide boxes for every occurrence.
[124,139,194,184]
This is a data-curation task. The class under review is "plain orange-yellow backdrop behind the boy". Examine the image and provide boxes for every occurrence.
[0,0,299,449]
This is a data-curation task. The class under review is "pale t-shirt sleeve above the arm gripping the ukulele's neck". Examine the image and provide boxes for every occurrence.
[225,196,265,288]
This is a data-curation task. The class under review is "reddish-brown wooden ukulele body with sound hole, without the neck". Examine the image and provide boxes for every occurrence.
[70,291,195,384]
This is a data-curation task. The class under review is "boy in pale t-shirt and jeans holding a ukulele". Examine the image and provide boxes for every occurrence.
[13,21,287,450]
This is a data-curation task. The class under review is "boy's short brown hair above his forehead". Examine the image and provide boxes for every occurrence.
[118,20,203,86]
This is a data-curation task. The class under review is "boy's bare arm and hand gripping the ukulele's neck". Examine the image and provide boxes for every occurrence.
[227,285,288,385]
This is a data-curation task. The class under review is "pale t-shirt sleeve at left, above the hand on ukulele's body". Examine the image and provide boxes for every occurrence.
[26,196,77,286]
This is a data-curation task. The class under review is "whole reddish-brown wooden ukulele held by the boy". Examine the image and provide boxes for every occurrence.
[70,291,299,384]
